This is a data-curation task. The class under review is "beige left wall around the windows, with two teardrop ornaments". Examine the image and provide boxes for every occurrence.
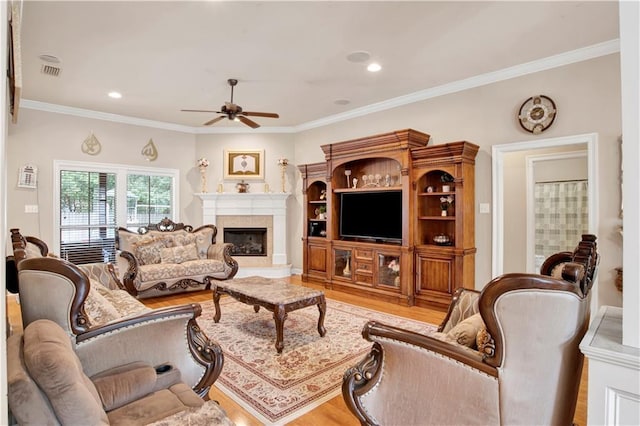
[7,109,202,243]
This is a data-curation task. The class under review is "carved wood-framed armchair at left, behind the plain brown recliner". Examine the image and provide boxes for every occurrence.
[17,253,223,396]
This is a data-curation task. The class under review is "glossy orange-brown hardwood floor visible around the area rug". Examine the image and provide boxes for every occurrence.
[7,275,587,426]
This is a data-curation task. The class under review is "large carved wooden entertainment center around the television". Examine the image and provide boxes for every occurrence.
[298,129,478,306]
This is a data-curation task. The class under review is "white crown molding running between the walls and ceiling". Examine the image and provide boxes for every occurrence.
[20,39,620,134]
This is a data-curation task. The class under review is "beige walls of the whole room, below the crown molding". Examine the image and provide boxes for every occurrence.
[7,54,621,306]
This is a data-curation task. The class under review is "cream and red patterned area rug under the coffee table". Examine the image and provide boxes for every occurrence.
[198,297,436,425]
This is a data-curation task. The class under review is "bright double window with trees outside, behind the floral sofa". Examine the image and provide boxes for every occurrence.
[53,161,179,264]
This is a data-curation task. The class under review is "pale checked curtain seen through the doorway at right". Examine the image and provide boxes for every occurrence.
[535,180,589,266]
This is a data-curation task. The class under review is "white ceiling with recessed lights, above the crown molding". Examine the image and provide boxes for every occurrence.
[21,0,618,131]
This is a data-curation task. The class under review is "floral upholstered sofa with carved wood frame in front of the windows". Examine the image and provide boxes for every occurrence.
[116,218,238,298]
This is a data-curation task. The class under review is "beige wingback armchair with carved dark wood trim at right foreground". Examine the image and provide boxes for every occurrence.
[342,235,599,426]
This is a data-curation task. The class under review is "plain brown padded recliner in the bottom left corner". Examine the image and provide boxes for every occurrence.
[7,319,233,426]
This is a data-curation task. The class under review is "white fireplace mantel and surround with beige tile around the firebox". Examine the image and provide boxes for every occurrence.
[195,192,291,278]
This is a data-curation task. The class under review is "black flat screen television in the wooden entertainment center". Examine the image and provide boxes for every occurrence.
[340,190,402,243]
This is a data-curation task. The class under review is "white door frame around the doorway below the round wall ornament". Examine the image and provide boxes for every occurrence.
[491,133,598,280]
